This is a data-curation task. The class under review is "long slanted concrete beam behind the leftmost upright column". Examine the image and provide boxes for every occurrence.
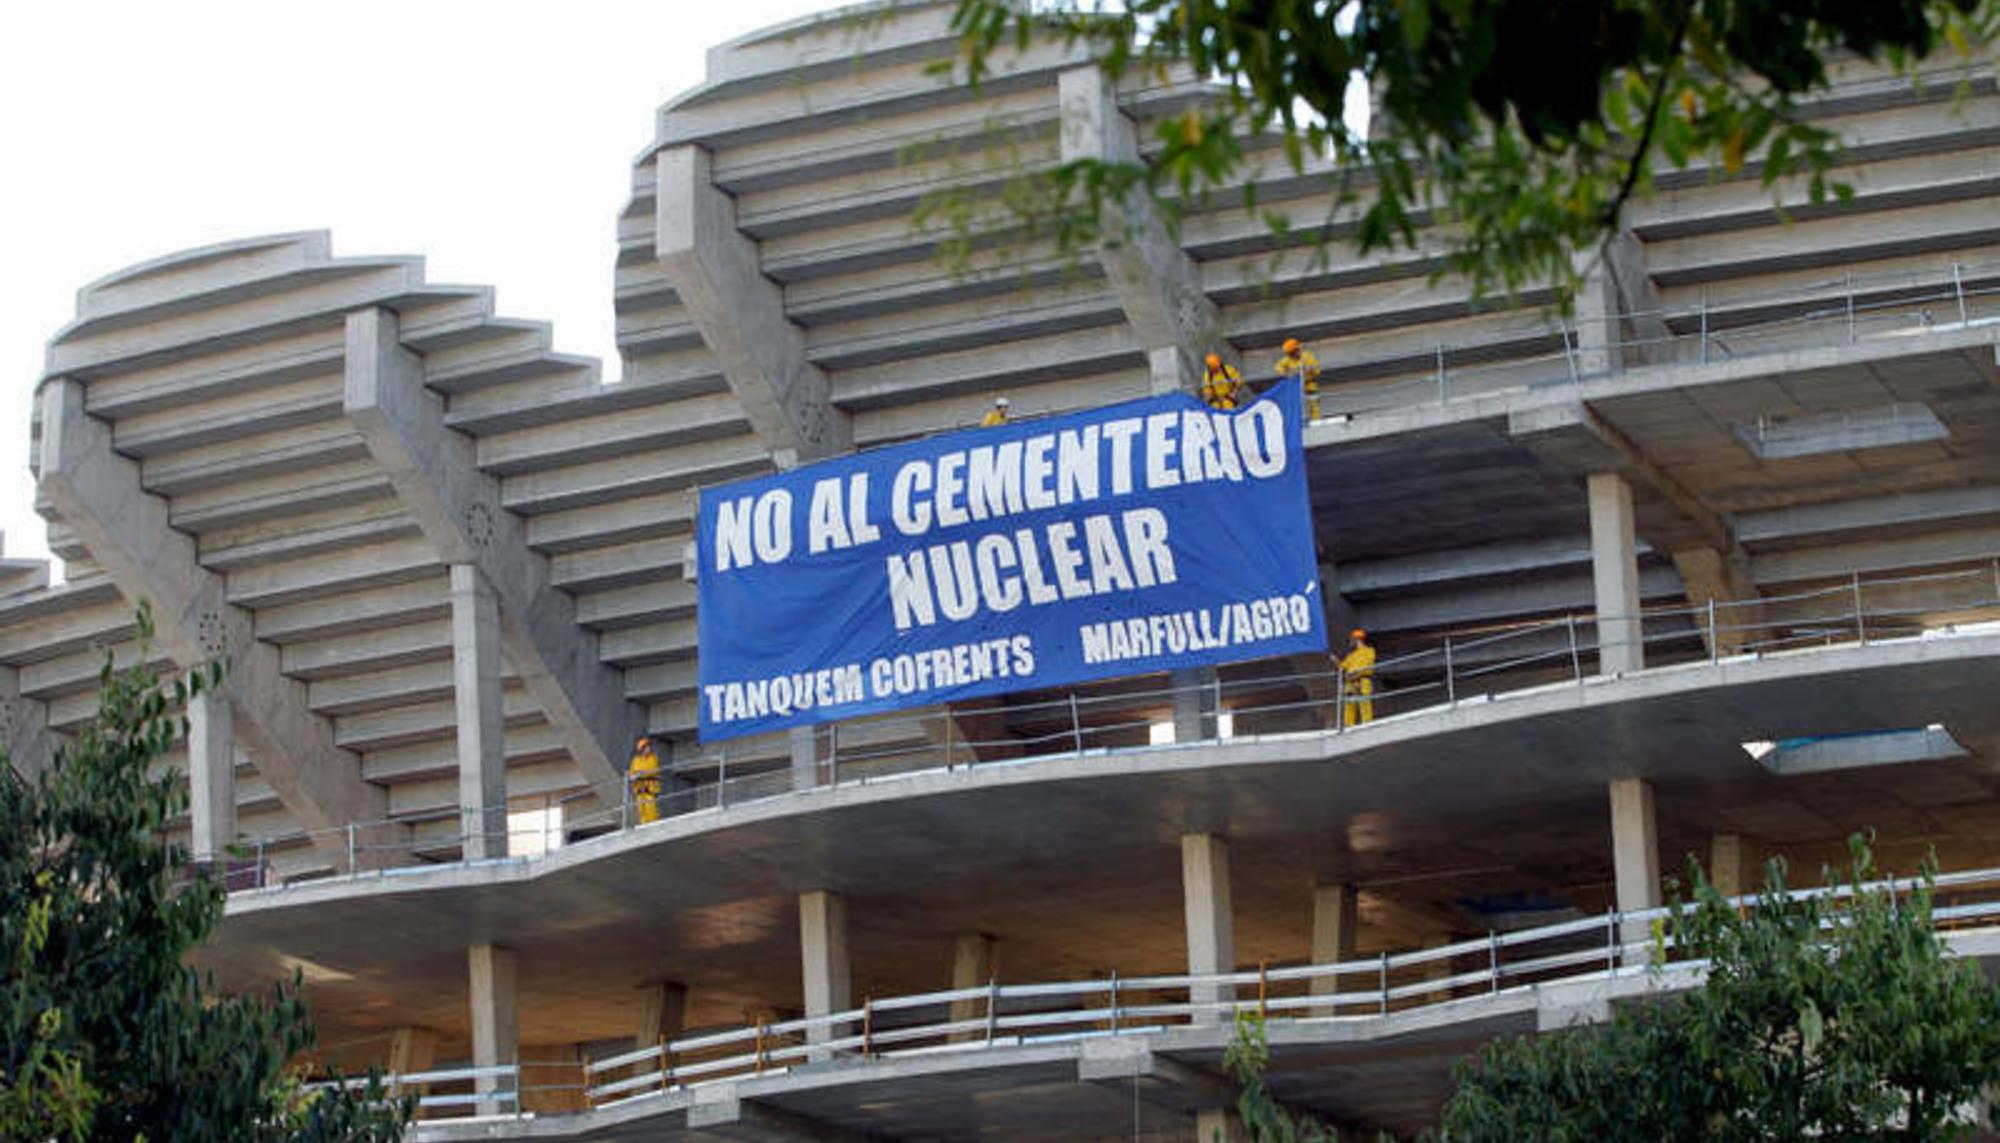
[38,378,386,851]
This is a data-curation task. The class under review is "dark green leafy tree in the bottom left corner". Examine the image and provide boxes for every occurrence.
[0,609,410,1143]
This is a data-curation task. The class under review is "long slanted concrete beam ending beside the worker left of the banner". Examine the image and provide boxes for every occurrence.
[344,310,646,805]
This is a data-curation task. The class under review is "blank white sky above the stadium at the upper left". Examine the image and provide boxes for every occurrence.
[0,0,836,571]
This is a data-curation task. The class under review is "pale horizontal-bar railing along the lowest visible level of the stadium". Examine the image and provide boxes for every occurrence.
[582,869,2000,1107]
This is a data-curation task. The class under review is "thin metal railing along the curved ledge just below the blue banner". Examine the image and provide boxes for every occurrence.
[228,558,2000,891]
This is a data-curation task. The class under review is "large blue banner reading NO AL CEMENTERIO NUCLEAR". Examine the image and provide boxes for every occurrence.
[696,380,1326,741]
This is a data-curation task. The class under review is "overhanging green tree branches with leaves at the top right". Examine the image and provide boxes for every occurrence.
[940,0,2000,303]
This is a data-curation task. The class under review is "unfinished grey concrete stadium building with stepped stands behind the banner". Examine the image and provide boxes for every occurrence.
[11,2,2000,1139]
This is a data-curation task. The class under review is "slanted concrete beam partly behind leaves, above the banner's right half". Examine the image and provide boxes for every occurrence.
[1058,66,1236,392]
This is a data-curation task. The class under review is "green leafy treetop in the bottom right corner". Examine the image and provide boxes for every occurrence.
[1442,841,2000,1143]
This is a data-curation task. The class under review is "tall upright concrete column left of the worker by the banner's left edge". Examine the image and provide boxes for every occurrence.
[452,564,506,861]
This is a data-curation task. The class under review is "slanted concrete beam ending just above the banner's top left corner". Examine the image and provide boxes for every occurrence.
[654,144,854,468]
